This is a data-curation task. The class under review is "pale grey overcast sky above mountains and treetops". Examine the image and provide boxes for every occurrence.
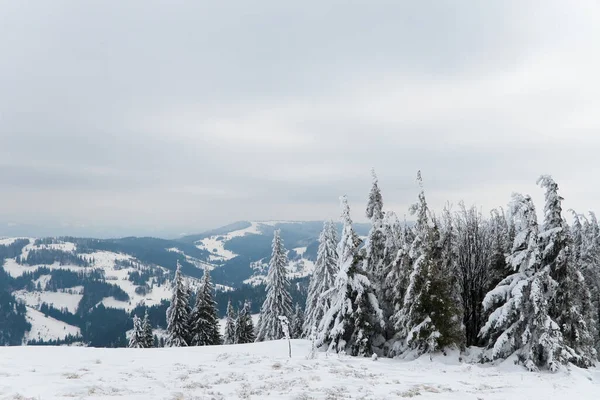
[0,0,600,236]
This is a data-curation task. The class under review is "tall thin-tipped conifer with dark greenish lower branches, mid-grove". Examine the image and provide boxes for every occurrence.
[393,171,462,354]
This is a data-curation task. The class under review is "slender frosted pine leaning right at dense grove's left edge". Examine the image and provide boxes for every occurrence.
[304,221,338,335]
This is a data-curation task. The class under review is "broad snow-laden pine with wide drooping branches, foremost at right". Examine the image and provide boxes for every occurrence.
[480,194,567,371]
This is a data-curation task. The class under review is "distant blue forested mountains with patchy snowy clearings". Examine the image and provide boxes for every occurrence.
[0,221,369,347]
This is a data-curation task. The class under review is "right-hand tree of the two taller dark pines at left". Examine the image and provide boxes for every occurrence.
[189,268,221,346]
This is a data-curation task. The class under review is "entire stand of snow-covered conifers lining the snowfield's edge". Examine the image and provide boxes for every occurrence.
[157,172,600,371]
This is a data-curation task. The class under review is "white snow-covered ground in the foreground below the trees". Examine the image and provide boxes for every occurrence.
[0,340,600,400]
